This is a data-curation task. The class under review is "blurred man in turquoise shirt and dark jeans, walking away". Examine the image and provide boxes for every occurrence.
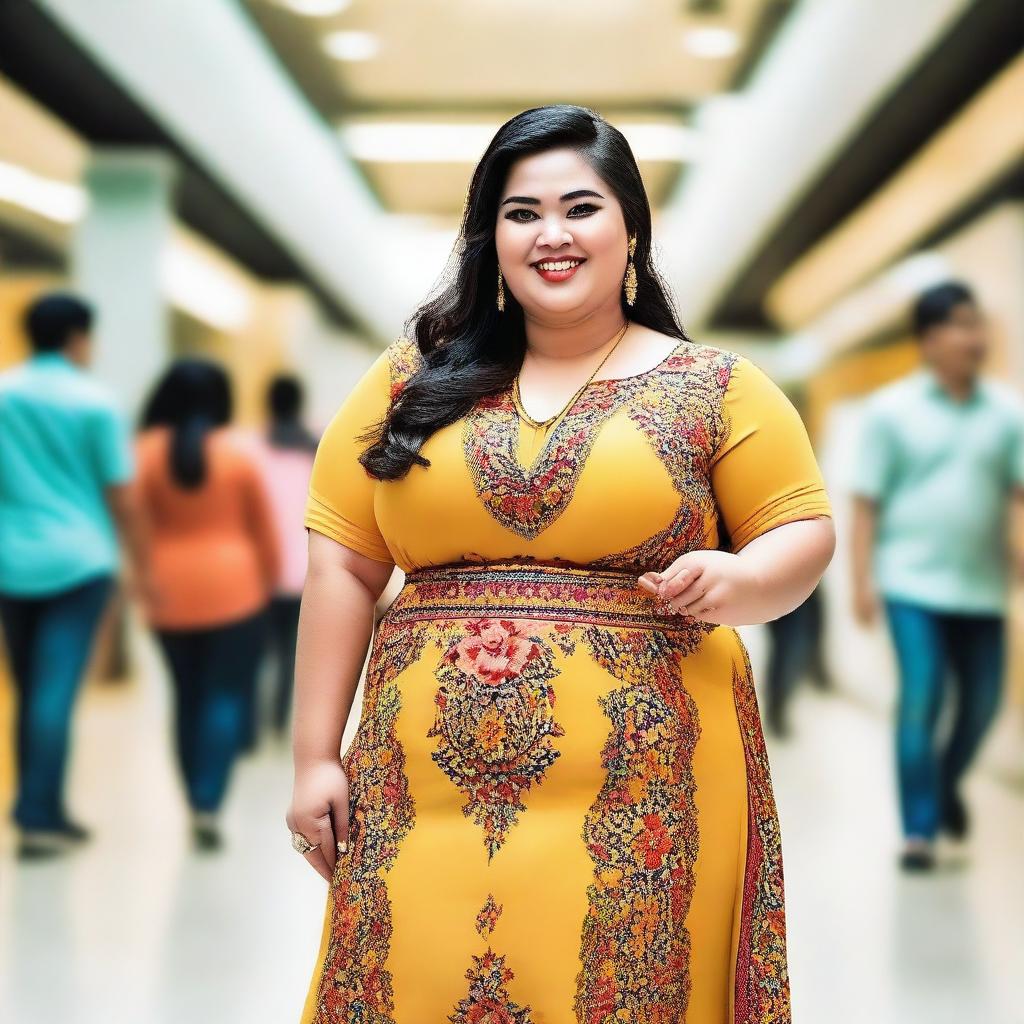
[0,294,146,857]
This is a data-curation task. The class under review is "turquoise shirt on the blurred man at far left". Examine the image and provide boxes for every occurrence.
[0,353,133,597]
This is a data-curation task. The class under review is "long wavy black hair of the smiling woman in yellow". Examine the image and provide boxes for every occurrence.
[359,103,688,480]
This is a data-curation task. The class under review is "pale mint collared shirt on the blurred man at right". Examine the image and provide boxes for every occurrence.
[851,365,1024,613]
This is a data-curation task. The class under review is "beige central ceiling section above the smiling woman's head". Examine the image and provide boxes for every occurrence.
[246,0,778,219]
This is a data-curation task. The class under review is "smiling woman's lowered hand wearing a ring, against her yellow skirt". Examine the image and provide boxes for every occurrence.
[285,761,348,883]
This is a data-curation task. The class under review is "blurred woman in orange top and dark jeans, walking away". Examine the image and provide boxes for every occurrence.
[137,359,279,850]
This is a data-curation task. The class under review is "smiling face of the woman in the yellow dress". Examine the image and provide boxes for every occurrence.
[495,148,629,322]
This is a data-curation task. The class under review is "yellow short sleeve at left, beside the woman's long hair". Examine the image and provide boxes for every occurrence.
[303,342,398,562]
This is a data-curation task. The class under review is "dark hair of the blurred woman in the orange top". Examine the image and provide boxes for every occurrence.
[141,358,231,489]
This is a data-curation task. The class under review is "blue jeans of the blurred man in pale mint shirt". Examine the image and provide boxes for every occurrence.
[884,598,1006,839]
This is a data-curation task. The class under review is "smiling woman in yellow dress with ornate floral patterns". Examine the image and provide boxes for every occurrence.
[286,104,835,1024]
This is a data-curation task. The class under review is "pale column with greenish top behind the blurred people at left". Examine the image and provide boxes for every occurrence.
[72,148,176,417]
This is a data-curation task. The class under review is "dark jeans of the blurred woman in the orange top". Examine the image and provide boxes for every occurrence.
[157,611,265,812]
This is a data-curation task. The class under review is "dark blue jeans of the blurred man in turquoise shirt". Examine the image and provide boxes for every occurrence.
[0,575,114,828]
